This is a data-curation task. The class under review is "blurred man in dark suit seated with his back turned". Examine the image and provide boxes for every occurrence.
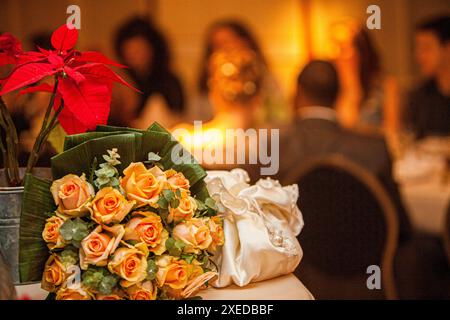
[279,60,411,245]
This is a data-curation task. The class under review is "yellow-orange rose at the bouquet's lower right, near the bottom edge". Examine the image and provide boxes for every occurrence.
[156,255,189,290]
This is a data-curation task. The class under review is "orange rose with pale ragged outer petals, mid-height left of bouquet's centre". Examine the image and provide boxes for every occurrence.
[80,225,125,270]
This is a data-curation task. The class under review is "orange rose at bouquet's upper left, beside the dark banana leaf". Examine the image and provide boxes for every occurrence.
[50,174,95,217]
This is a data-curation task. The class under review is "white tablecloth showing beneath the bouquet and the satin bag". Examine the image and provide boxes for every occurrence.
[16,274,314,300]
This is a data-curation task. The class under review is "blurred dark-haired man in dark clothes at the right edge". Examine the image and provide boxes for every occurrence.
[406,15,450,139]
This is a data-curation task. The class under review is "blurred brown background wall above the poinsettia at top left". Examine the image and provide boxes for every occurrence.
[0,0,156,56]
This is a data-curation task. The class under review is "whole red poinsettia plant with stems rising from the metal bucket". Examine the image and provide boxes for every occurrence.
[0,25,136,186]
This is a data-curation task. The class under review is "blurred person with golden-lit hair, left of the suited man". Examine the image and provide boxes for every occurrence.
[173,47,264,179]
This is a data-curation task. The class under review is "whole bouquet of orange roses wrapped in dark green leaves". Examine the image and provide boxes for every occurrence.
[20,125,224,300]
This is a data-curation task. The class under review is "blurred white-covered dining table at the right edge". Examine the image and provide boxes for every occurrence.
[394,138,450,236]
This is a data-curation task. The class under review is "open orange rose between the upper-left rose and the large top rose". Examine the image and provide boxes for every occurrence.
[90,187,134,224]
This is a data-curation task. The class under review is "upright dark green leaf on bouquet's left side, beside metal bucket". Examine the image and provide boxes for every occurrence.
[19,174,56,283]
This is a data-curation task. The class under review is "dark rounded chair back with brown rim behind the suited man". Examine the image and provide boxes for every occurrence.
[290,156,399,299]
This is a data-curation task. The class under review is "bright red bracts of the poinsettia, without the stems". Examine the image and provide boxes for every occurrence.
[0,25,138,134]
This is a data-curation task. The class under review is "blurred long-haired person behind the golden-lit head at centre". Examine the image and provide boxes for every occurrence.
[191,20,288,125]
